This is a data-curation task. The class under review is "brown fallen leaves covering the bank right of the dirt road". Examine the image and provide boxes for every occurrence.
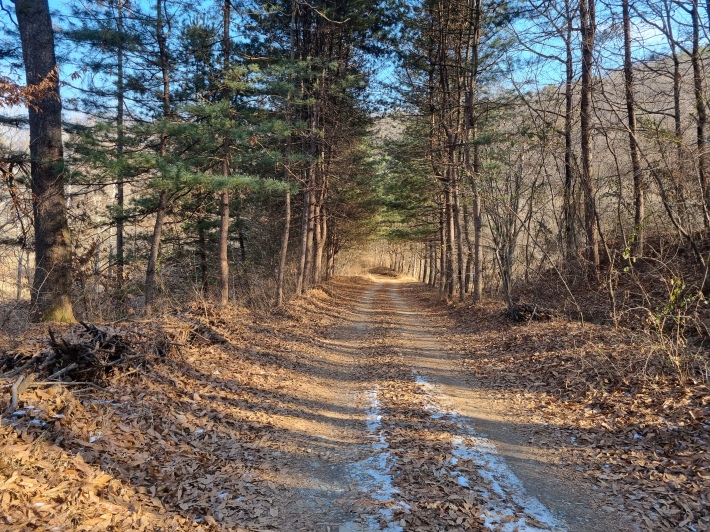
[425,290,710,530]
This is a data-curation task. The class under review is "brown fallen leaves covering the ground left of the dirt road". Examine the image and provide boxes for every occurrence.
[0,291,356,531]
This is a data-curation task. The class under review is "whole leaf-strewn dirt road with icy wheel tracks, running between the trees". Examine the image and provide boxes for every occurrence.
[284,279,634,532]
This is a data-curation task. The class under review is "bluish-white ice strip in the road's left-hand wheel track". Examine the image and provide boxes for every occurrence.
[339,388,406,532]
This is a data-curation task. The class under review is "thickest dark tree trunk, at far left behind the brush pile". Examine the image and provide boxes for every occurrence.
[15,0,74,322]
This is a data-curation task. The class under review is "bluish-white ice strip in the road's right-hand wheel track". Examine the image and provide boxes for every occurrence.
[414,373,564,532]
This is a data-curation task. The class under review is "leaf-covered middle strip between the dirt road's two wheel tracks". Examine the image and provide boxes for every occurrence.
[358,288,483,531]
